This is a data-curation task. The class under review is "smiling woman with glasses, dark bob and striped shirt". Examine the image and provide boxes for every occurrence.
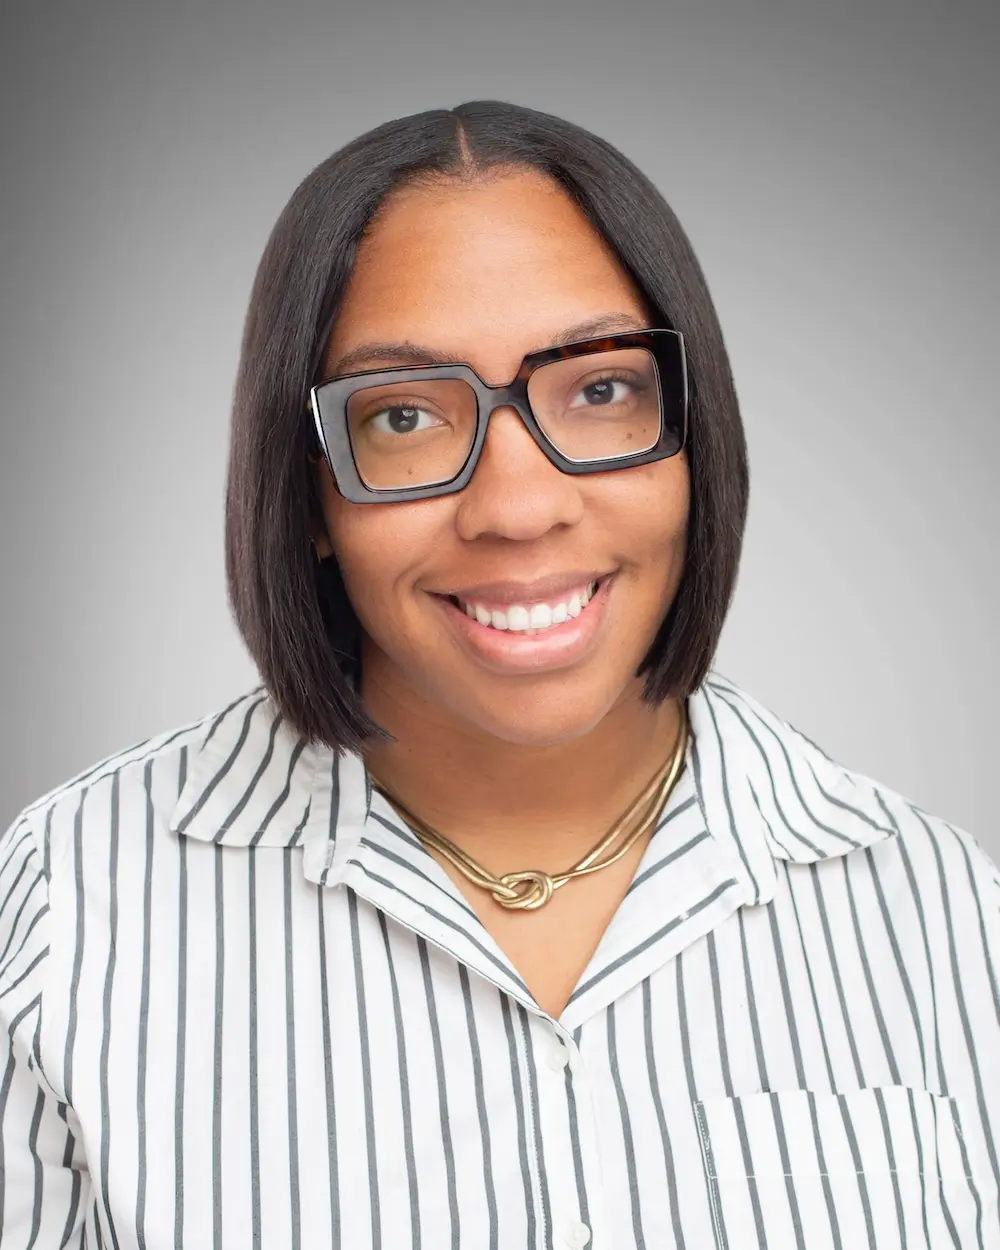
[0,103,1000,1250]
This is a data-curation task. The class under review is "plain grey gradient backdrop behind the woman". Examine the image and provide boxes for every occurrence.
[0,0,1000,858]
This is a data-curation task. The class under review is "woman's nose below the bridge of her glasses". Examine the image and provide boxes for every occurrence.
[456,406,583,541]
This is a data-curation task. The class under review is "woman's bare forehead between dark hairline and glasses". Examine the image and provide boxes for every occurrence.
[325,174,650,375]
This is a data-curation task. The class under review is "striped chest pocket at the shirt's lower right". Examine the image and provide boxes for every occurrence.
[695,1085,980,1250]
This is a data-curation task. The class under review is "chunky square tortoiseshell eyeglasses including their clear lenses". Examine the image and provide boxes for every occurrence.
[310,330,688,504]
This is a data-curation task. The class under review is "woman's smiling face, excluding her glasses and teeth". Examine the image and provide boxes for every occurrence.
[316,171,689,746]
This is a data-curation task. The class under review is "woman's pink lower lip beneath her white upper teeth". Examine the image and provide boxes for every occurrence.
[434,574,615,673]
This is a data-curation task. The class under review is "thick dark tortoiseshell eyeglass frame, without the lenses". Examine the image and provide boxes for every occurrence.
[310,329,688,504]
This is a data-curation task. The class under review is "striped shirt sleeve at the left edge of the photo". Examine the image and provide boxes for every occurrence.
[0,816,90,1250]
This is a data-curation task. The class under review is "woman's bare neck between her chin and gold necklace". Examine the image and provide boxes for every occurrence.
[363,670,680,873]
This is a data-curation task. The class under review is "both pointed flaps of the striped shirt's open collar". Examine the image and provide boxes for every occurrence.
[169,671,895,903]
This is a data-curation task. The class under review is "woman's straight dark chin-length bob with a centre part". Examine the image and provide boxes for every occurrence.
[225,100,749,751]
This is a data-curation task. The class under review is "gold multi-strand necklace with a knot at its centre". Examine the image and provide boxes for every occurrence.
[369,703,688,911]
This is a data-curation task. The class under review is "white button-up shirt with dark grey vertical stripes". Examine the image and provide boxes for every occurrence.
[0,673,1000,1250]
